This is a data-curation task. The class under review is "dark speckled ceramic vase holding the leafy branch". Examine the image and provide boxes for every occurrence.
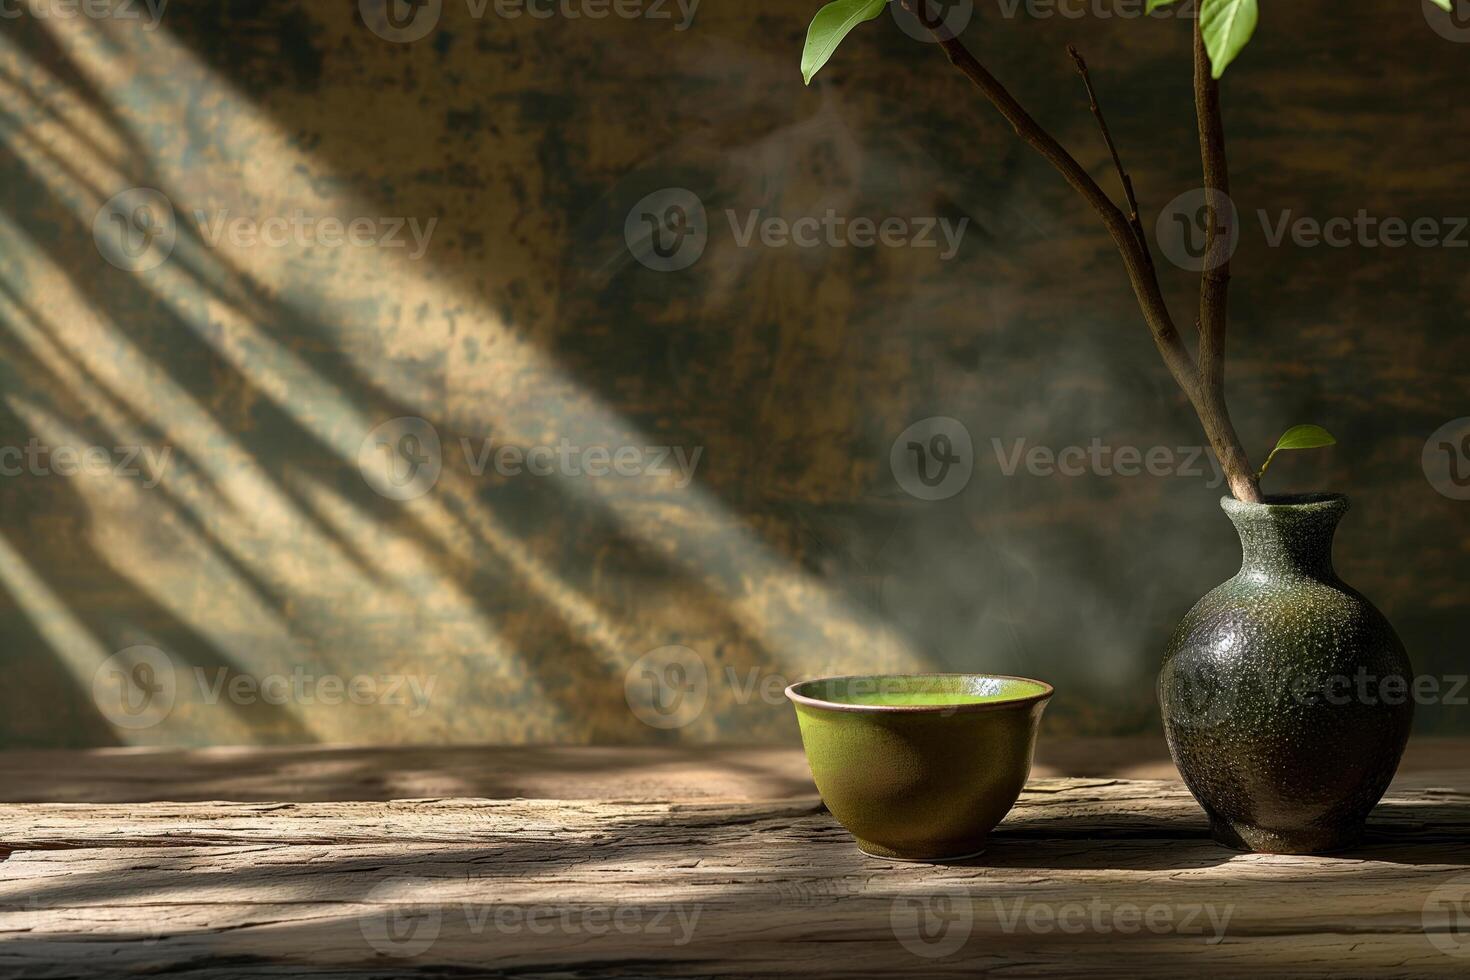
[1158,494,1414,854]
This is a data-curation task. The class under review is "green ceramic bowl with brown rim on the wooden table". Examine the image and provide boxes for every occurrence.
[786,674,1051,862]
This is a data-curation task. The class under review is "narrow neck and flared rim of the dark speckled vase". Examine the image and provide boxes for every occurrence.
[1222,494,1348,579]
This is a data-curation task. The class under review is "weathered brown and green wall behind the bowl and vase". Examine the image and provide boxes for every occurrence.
[0,0,1470,746]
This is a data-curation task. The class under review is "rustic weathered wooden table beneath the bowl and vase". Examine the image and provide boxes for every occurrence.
[0,739,1470,979]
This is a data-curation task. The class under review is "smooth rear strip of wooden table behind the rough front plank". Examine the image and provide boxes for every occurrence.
[0,736,1470,804]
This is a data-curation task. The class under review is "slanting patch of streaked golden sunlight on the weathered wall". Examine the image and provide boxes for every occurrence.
[0,7,916,743]
